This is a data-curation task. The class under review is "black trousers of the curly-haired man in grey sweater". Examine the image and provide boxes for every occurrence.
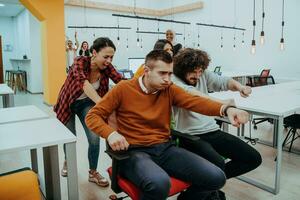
[180,130,262,179]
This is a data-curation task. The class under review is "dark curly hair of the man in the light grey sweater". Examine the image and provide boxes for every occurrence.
[173,48,210,82]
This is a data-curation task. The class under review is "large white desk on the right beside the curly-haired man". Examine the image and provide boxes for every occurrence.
[210,81,300,194]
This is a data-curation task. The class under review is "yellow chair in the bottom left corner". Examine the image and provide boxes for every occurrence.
[0,168,42,200]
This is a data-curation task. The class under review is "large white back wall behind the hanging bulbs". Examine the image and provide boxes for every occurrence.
[65,0,300,79]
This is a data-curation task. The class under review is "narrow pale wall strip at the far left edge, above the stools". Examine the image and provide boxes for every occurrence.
[0,17,16,72]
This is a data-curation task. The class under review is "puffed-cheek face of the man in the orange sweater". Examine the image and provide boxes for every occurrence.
[145,60,173,91]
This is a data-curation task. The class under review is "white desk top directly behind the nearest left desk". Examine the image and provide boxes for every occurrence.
[0,105,49,124]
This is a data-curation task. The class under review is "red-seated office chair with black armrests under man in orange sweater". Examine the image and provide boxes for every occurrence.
[105,130,198,200]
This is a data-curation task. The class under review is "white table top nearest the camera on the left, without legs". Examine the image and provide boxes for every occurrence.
[0,118,76,154]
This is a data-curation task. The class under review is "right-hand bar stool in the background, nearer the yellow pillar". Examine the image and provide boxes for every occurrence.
[10,70,27,93]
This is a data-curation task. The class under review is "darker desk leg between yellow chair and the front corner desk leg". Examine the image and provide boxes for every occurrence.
[43,145,61,200]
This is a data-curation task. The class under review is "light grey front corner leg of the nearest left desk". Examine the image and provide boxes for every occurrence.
[66,142,79,200]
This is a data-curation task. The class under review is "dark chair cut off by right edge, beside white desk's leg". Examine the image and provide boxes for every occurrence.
[282,114,300,152]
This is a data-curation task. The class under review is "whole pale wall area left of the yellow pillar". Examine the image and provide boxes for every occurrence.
[0,9,43,93]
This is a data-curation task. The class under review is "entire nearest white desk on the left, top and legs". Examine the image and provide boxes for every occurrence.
[0,118,79,200]
